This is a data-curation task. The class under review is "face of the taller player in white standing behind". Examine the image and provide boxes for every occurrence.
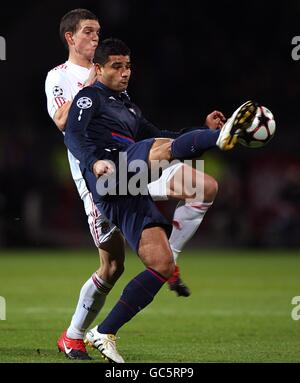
[72,20,100,60]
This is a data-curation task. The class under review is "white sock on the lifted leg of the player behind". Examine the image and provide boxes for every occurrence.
[169,201,213,263]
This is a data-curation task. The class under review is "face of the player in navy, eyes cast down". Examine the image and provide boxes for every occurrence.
[99,55,131,92]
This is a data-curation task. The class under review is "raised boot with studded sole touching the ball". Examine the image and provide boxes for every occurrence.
[217,101,258,150]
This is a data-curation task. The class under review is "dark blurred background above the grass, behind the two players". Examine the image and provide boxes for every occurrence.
[0,0,300,248]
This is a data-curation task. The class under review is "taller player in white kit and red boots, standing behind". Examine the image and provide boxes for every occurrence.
[45,9,217,359]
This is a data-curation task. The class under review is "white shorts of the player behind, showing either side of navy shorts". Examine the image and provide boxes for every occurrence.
[82,163,183,247]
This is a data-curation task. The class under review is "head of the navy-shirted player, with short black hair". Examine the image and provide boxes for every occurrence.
[94,38,131,92]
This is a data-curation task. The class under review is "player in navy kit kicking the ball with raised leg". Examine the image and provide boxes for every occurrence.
[65,39,256,363]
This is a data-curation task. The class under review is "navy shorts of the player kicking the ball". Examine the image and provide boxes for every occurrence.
[85,138,172,251]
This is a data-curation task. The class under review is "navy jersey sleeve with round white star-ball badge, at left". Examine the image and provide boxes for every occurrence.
[64,87,100,171]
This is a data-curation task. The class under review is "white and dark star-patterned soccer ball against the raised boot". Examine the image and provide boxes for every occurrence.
[238,105,276,148]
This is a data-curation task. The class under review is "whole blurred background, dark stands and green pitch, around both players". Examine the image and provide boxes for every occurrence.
[0,0,300,361]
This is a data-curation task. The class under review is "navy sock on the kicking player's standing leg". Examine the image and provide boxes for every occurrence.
[98,268,167,334]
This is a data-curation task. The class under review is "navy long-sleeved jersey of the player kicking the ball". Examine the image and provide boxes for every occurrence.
[65,82,206,170]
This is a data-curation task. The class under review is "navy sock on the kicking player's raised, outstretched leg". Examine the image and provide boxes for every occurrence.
[171,129,220,159]
